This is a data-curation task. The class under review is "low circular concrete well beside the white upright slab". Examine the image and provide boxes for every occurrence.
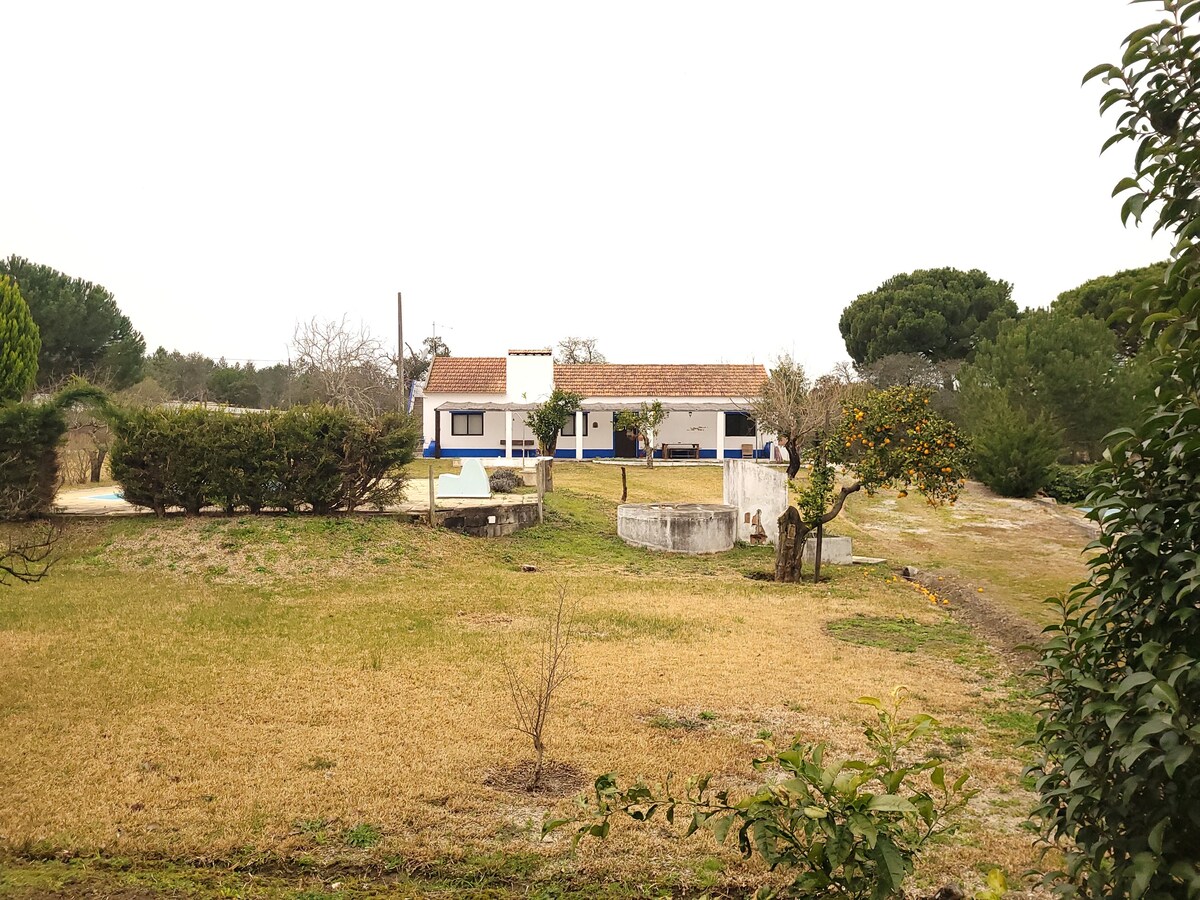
[617,503,738,553]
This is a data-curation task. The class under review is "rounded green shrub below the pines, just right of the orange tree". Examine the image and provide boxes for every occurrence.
[971,397,1062,497]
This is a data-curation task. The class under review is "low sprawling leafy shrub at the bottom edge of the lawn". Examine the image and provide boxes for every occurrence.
[544,689,974,900]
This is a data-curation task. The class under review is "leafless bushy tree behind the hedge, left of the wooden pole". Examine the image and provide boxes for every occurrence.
[292,316,397,416]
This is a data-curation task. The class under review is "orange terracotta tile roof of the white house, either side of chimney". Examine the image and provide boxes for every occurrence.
[425,356,767,397]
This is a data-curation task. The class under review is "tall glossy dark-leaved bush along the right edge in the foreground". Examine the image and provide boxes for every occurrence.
[1032,0,1200,900]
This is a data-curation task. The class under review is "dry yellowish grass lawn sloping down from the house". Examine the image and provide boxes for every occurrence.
[0,463,1086,896]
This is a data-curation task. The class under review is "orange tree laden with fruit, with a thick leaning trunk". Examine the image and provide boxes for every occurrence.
[775,386,970,582]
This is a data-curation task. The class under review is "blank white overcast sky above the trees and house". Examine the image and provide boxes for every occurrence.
[0,0,1166,372]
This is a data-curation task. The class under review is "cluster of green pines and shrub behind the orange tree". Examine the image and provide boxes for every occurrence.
[840,263,1166,496]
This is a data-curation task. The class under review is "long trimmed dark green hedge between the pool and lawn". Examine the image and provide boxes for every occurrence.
[109,406,420,516]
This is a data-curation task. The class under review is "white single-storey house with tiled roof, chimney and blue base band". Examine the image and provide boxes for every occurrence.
[422,349,774,460]
